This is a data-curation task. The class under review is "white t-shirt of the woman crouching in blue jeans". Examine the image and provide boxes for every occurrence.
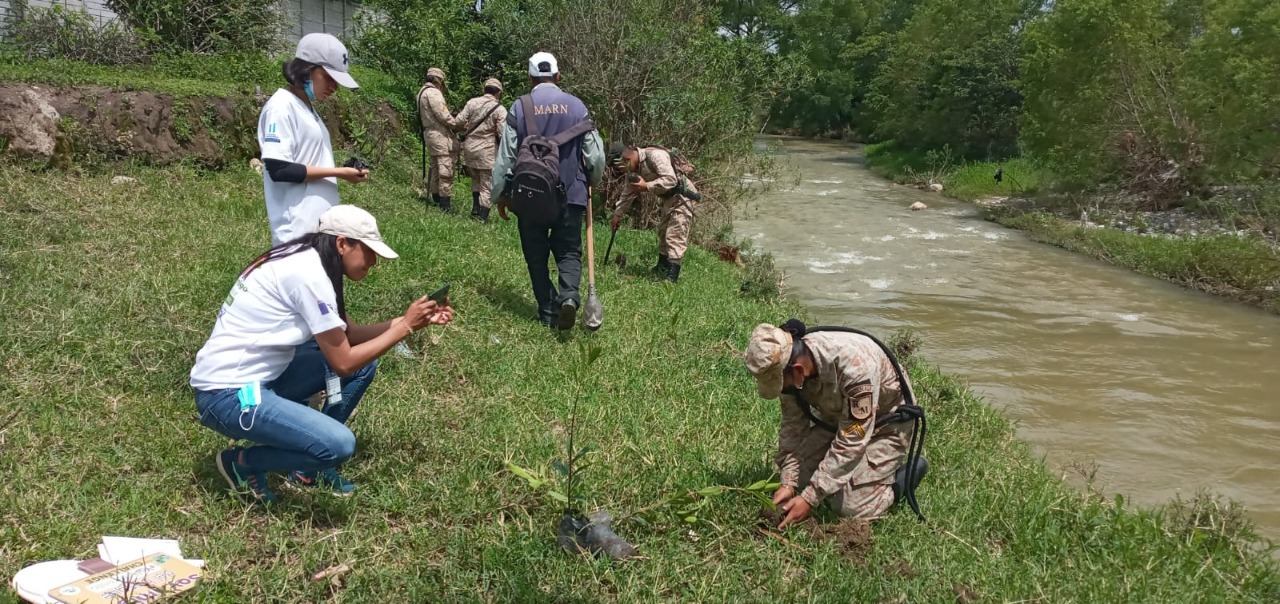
[191,250,347,390]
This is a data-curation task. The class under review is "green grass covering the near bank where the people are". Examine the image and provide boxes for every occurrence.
[0,158,1280,603]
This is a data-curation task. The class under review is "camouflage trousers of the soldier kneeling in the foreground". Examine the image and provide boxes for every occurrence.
[796,427,911,520]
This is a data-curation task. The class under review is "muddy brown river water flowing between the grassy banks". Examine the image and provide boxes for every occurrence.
[735,138,1280,540]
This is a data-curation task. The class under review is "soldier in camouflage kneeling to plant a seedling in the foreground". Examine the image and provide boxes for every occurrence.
[744,324,914,526]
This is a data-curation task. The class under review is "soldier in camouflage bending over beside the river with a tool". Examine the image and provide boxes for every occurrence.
[609,142,699,283]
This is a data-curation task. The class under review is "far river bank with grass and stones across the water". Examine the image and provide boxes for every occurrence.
[865,145,1280,312]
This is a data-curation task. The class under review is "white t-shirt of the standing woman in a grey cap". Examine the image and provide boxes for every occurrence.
[257,88,339,246]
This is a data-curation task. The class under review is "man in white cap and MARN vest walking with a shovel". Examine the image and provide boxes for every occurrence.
[493,52,604,330]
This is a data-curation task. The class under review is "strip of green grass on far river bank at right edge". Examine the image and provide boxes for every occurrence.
[993,211,1280,312]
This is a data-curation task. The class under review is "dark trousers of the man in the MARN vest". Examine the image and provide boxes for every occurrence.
[520,205,586,322]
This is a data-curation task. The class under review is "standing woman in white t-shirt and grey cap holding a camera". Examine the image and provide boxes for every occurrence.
[257,33,369,246]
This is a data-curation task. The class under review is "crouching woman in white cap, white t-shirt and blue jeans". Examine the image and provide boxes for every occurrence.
[191,206,453,503]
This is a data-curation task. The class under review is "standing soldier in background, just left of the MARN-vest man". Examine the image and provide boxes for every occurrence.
[454,78,507,223]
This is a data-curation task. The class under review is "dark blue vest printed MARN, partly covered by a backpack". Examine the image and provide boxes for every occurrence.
[507,84,589,207]
